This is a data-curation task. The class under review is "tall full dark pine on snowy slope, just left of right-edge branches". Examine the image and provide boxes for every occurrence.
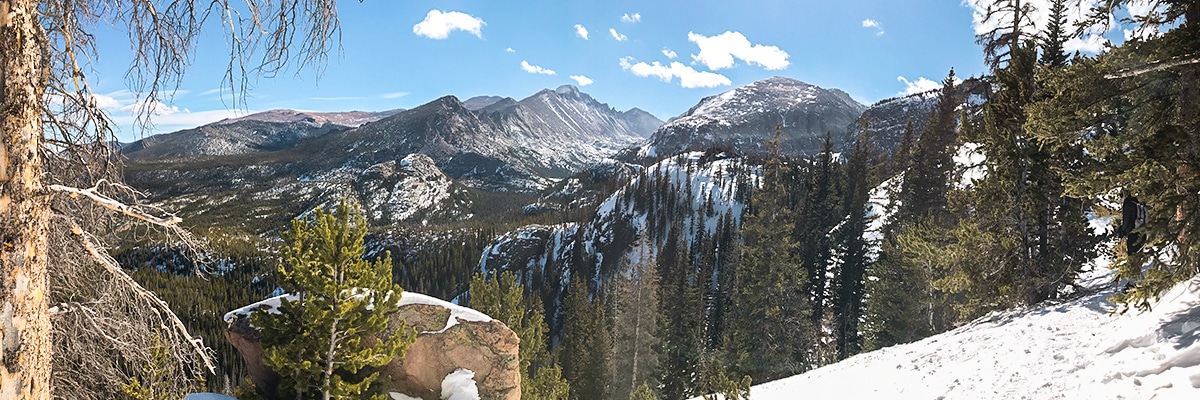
[958,10,1093,306]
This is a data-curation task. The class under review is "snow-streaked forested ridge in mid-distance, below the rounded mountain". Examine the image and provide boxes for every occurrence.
[479,153,760,329]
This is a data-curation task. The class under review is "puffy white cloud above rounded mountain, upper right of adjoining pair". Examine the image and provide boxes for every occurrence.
[688,31,791,71]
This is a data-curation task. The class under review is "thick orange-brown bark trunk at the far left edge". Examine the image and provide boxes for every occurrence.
[0,0,50,399]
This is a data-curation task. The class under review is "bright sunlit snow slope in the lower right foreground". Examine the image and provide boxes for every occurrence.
[750,264,1200,400]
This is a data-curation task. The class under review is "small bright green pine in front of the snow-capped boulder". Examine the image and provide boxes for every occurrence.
[251,199,415,400]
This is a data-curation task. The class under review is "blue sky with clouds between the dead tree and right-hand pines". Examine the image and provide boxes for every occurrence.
[91,0,1137,141]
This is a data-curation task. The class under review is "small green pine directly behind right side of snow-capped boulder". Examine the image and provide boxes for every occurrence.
[468,271,570,400]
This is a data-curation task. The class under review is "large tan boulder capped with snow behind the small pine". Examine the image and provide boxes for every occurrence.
[224,292,521,400]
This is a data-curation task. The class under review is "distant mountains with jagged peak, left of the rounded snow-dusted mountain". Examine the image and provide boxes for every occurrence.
[122,86,662,225]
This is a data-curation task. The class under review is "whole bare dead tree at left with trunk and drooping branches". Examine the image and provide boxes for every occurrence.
[0,0,340,399]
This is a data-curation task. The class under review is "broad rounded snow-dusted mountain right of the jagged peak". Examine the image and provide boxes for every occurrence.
[618,77,866,162]
